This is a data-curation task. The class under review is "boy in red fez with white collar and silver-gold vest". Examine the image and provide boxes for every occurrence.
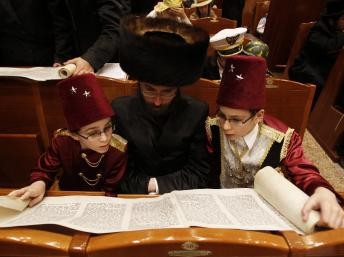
[206,55,344,228]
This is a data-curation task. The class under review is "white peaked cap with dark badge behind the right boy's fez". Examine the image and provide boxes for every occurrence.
[210,27,247,57]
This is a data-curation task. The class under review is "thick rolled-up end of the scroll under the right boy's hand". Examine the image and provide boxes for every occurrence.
[254,167,320,234]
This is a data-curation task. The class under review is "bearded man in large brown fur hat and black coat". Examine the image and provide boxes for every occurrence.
[112,17,210,194]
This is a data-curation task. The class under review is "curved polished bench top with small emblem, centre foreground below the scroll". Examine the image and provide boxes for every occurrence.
[87,228,289,257]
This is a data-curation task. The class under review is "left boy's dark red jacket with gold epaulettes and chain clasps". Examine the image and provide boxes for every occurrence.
[30,130,127,195]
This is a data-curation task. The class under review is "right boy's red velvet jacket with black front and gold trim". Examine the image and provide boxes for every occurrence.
[207,115,344,203]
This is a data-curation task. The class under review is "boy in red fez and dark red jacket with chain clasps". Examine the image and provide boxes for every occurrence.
[10,74,127,206]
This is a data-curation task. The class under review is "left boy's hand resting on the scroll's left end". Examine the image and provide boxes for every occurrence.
[8,180,45,207]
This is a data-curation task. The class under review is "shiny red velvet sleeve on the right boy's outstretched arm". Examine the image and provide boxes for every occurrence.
[282,132,343,202]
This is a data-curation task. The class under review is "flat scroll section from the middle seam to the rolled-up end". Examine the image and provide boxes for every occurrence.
[173,188,294,230]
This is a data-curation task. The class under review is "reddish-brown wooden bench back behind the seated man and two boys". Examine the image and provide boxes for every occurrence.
[0,77,314,187]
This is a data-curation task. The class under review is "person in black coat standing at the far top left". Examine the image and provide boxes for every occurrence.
[0,0,66,66]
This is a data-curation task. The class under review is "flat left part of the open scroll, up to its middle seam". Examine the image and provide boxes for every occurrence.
[0,194,187,233]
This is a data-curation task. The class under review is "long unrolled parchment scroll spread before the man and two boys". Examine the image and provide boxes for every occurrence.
[0,167,319,234]
